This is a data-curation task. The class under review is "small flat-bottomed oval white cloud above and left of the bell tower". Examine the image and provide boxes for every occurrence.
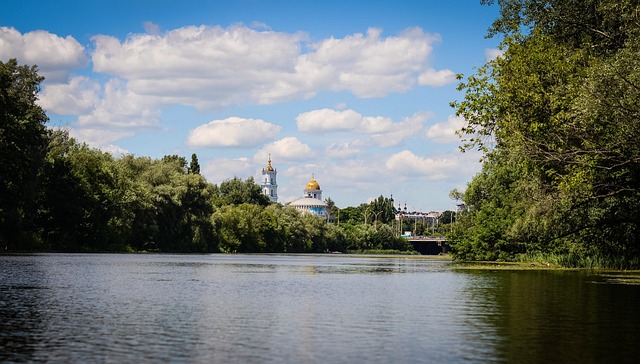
[187,117,281,147]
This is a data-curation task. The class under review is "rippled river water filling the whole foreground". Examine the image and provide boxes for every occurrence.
[0,255,640,363]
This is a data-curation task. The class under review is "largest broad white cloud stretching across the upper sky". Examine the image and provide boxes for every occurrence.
[87,26,439,109]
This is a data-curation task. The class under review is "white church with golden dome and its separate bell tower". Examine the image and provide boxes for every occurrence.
[261,156,330,220]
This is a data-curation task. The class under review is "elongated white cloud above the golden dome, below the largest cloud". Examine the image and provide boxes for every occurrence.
[296,109,431,147]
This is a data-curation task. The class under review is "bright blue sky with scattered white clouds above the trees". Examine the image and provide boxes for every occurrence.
[0,0,499,211]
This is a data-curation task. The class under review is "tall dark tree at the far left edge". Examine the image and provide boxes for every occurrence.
[0,59,48,250]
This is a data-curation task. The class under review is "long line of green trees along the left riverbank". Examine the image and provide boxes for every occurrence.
[0,60,412,253]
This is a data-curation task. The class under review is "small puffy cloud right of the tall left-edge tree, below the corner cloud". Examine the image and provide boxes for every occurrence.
[38,77,100,115]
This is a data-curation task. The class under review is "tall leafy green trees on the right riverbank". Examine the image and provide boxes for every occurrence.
[449,0,640,268]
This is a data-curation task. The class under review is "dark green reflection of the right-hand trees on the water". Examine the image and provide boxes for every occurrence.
[467,271,640,363]
